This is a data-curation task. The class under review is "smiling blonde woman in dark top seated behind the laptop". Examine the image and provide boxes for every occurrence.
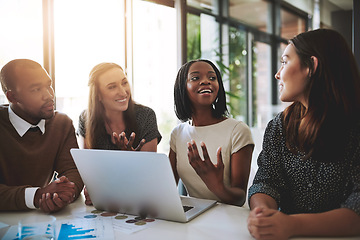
[78,63,161,205]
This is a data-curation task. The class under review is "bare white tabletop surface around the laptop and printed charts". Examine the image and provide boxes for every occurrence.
[0,196,360,240]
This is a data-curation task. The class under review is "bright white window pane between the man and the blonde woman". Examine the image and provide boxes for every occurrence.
[54,0,125,128]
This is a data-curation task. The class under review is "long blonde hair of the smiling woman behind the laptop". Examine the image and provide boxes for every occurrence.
[85,63,139,148]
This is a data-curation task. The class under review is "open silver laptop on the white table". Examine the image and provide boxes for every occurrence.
[70,149,216,222]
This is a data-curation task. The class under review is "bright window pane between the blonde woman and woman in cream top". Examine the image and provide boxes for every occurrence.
[133,0,178,154]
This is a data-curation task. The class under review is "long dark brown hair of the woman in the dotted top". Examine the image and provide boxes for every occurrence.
[283,29,360,161]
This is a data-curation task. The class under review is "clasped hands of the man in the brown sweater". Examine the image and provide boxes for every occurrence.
[34,176,75,213]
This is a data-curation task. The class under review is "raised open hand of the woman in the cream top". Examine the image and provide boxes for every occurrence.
[188,140,224,190]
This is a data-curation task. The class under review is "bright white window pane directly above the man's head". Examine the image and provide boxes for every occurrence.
[0,0,43,104]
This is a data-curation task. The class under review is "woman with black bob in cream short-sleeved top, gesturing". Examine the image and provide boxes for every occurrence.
[169,59,254,206]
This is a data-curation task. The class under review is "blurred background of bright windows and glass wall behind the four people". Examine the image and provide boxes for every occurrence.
[0,0,360,154]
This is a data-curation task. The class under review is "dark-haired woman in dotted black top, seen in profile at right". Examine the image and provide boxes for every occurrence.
[248,29,360,240]
